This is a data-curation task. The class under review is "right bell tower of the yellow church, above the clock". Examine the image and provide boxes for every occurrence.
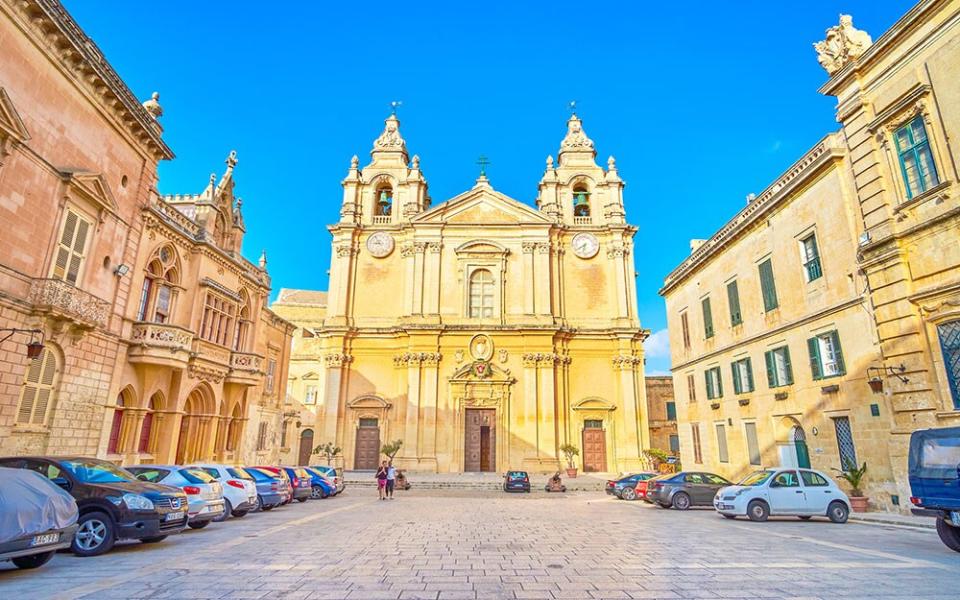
[537,113,625,226]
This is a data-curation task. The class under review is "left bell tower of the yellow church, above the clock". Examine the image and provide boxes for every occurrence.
[340,112,430,226]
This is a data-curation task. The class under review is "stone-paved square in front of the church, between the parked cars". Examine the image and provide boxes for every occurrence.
[0,488,960,600]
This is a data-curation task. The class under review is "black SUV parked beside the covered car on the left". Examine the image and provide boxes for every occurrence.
[0,456,187,556]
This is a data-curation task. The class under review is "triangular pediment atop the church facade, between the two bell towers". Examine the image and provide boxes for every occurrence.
[412,186,552,225]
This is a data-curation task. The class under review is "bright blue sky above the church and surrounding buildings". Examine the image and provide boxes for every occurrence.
[65,0,913,372]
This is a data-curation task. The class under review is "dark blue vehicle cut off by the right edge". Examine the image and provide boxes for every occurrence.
[908,427,960,552]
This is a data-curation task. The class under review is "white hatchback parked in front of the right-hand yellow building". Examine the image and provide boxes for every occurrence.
[713,468,850,523]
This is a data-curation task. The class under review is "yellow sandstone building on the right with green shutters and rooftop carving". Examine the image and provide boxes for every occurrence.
[661,0,960,510]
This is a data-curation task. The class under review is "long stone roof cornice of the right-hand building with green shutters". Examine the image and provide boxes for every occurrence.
[660,133,844,296]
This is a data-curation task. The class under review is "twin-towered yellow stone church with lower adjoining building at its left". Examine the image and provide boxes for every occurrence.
[272,114,649,472]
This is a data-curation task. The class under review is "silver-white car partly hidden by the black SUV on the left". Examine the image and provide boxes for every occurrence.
[127,465,224,529]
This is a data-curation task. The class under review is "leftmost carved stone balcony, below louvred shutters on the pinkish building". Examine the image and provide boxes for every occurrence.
[28,279,110,331]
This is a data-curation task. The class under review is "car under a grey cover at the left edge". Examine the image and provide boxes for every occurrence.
[0,467,80,569]
